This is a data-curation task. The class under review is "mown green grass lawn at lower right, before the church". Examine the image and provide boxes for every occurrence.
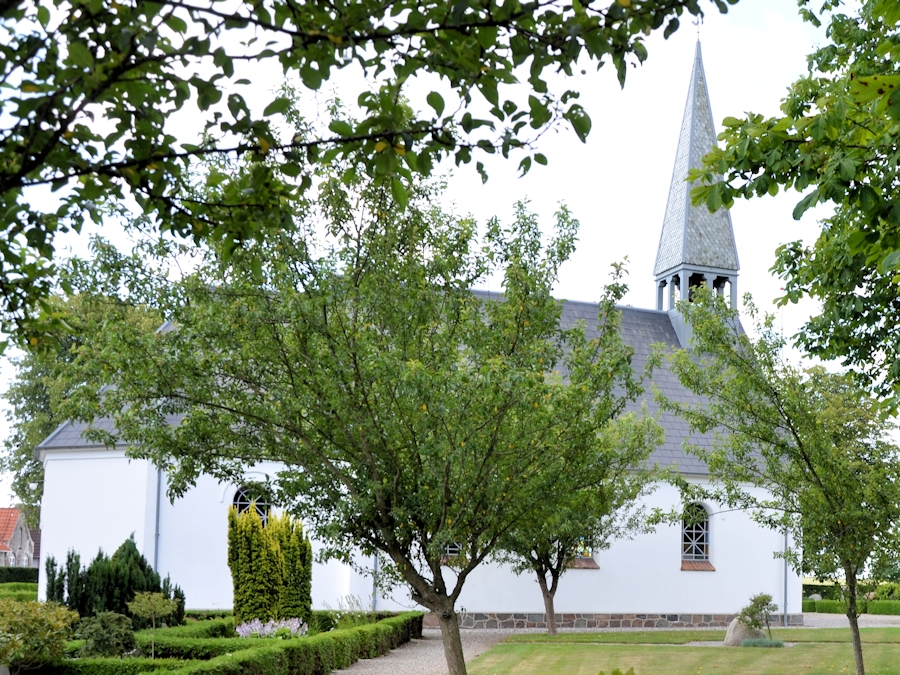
[469,628,900,675]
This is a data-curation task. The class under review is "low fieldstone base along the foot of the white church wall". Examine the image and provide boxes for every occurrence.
[425,612,803,628]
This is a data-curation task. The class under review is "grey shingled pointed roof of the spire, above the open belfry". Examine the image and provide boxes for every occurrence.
[653,40,740,277]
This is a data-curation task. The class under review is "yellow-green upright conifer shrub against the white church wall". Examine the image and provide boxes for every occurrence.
[228,508,312,625]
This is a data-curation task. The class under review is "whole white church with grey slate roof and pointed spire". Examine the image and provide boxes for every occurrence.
[36,42,803,628]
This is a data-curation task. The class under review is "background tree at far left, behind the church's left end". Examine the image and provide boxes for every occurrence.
[0,294,161,527]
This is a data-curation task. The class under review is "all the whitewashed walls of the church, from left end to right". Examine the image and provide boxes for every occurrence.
[40,450,801,614]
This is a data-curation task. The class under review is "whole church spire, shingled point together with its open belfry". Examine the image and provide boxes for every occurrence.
[654,40,740,309]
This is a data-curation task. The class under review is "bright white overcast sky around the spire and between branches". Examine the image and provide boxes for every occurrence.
[0,0,824,505]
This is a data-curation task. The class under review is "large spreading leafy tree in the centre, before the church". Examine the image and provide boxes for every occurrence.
[61,165,652,675]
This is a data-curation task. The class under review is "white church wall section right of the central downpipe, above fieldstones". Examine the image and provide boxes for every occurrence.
[378,486,802,614]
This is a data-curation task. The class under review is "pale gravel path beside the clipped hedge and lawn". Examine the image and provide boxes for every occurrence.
[334,614,900,675]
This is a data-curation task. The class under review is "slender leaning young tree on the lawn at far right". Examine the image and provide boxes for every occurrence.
[660,287,900,675]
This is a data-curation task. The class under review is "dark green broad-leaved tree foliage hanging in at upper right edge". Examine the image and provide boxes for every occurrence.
[691,0,900,407]
